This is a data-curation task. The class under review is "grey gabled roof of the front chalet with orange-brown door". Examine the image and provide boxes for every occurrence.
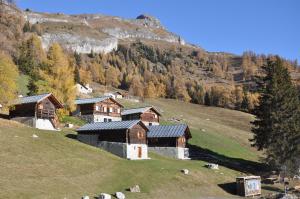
[77,120,148,131]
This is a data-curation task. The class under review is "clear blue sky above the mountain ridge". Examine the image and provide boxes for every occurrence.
[17,0,300,62]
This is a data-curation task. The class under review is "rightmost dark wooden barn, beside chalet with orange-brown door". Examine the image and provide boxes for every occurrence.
[148,124,192,159]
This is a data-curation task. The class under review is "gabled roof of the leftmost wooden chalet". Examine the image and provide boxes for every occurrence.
[12,93,63,108]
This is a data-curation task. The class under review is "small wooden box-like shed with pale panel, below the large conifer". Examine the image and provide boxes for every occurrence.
[236,176,261,197]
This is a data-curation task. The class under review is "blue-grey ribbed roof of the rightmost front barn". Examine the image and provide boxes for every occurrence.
[148,124,188,138]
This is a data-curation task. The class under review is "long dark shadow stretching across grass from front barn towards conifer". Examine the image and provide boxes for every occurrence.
[188,145,269,175]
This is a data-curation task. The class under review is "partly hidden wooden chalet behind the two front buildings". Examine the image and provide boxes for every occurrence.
[122,106,161,126]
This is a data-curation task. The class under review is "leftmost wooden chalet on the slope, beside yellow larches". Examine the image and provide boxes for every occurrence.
[9,93,63,130]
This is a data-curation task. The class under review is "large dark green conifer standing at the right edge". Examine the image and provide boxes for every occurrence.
[251,57,300,175]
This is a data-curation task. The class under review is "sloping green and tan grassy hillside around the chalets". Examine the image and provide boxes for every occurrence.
[0,100,276,199]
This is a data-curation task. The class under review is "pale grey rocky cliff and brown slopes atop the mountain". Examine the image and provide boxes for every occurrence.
[24,12,185,53]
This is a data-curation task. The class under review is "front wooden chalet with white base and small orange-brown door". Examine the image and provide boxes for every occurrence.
[77,120,148,160]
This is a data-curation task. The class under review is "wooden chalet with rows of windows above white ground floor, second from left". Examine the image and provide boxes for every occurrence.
[73,96,123,123]
